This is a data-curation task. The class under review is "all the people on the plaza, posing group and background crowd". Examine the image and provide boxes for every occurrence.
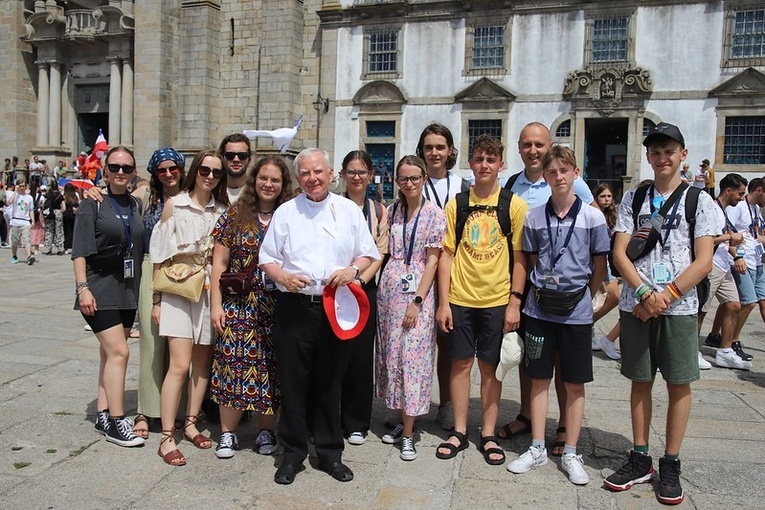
[5,122,765,504]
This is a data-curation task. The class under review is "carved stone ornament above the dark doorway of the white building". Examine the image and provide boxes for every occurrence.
[563,67,653,116]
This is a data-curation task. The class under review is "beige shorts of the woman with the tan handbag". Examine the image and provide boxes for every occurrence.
[159,291,212,345]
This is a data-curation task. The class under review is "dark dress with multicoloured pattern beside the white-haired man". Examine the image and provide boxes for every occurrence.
[210,209,281,414]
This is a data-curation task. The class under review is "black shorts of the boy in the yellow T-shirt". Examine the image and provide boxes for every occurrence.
[449,305,507,365]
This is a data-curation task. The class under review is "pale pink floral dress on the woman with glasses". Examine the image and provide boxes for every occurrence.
[375,197,446,416]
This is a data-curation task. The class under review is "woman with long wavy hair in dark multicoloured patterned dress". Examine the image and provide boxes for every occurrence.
[210,156,293,459]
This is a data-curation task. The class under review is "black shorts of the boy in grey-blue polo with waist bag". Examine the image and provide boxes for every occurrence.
[523,316,592,384]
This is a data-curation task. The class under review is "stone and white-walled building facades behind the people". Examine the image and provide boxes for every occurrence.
[0,0,765,197]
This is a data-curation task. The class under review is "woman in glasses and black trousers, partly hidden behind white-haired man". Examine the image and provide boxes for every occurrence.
[340,151,388,445]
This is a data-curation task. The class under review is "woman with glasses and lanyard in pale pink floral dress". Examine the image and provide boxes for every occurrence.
[376,156,446,460]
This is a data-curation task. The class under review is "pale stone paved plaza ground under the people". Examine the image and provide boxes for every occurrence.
[0,250,765,509]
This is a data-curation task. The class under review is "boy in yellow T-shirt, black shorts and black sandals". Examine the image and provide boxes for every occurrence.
[436,135,528,465]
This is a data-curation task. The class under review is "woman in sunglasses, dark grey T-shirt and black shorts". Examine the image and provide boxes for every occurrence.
[72,146,146,446]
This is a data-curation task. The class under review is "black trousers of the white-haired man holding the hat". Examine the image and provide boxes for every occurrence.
[274,292,352,464]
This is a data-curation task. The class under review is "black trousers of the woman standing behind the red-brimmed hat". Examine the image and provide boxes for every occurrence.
[340,280,377,437]
